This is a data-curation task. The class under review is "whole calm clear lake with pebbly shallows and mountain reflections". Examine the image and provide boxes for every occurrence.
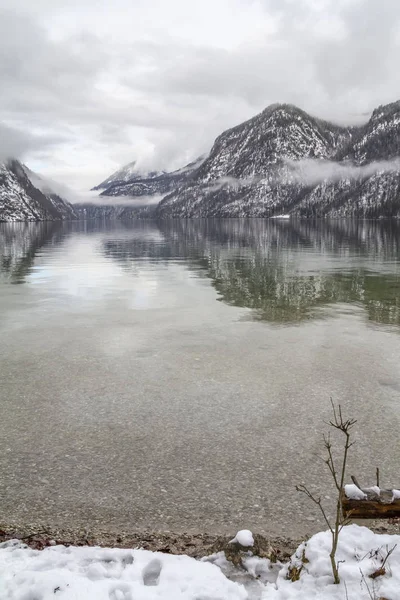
[0,219,400,535]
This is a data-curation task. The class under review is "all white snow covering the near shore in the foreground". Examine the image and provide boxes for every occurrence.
[0,525,400,600]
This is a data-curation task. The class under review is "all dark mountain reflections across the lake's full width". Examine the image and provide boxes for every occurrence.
[0,219,400,325]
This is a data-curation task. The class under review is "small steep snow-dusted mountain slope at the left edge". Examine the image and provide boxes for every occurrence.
[0,159,77,221]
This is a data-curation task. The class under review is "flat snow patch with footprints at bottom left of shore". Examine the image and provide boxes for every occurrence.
[0,541,247,600]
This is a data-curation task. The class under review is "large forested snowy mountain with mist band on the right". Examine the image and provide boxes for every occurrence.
[157,101,400,217]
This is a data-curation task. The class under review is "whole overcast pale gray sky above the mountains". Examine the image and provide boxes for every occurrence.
[0,0,400,189]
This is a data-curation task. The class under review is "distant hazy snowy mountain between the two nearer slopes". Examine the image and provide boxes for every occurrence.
[93,156,205,197]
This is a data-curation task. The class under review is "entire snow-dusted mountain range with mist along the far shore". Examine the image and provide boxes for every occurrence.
[0,101,400,220]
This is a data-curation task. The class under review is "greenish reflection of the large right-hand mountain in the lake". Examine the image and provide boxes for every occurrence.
[104,219,400,325]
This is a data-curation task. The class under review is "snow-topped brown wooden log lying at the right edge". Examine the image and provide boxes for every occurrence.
[341,488,400,519]
